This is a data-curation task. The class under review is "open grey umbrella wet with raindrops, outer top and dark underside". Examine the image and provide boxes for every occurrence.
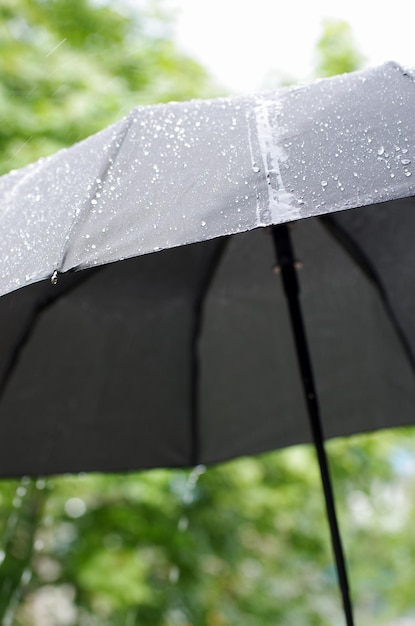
[0,63,415,623]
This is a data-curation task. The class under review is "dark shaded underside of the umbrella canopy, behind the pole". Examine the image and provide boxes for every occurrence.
[0,199,415,476]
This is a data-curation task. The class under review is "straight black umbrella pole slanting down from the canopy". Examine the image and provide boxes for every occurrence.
[272,224,354,626]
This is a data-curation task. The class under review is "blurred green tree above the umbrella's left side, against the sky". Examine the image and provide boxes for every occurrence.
[0,0,219,173]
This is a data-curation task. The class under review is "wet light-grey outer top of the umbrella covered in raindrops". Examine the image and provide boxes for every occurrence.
[0,63,415,294]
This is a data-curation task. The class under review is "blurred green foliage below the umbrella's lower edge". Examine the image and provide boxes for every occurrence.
[0,430,415,626]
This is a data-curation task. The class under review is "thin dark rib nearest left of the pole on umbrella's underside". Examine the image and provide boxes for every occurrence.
[190,235,230,467]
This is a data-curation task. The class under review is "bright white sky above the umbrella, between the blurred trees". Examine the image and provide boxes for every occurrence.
[165,0,415,93]
